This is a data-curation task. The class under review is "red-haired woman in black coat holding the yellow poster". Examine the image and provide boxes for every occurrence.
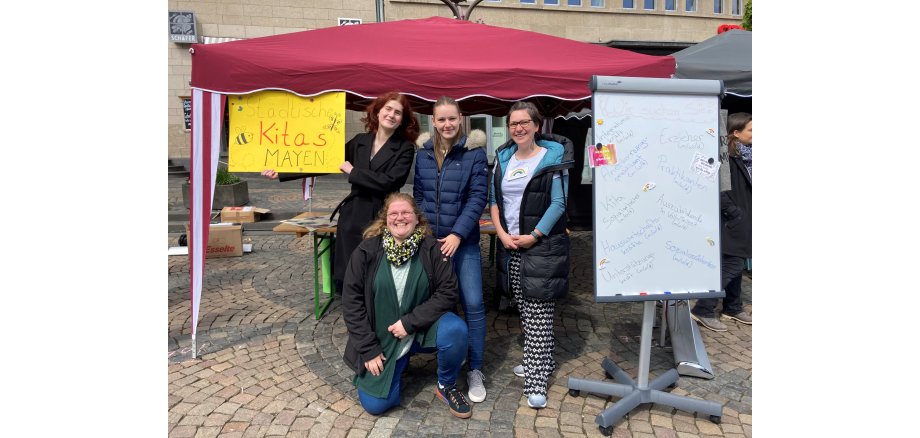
[262,91,419,293]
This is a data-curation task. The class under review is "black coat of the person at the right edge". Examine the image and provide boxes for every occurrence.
[719,157,752,258]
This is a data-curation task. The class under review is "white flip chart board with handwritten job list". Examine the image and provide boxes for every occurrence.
[586,76,724,302]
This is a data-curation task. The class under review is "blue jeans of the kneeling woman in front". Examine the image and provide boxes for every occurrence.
[358,312,469,415]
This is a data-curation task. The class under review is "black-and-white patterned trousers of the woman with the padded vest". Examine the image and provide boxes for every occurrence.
[508,250,556,396]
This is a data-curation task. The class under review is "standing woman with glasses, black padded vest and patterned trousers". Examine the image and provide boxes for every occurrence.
[489,102,574,409]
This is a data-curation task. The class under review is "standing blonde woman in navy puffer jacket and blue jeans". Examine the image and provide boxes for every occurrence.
[412,96,489,403]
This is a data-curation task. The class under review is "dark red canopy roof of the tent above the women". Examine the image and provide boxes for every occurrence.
[191,17,674,116]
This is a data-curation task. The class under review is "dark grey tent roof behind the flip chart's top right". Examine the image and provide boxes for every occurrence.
[671,29,753,97]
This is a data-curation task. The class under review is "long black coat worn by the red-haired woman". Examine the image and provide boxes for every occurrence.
[332,133,415,282]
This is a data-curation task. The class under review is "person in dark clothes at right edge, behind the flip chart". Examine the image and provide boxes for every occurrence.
[690,113,753,332]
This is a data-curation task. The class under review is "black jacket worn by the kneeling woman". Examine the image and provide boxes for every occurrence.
[342,236,460,375]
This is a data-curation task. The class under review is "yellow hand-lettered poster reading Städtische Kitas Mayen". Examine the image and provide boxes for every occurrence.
[227,91,345,173]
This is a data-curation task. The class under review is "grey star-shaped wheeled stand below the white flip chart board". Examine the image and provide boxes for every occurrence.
[568,301,722,436]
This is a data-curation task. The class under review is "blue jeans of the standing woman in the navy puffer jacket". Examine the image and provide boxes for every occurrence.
[454,242,486,370]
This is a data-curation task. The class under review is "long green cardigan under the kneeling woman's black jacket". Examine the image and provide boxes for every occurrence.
[353,252,438,398]
